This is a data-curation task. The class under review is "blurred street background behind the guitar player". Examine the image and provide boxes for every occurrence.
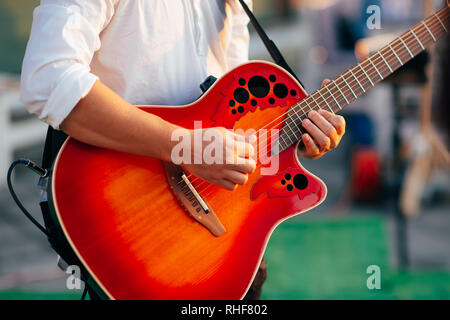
[0,0,450,299]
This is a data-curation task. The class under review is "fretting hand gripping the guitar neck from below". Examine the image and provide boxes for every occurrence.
[300,79,345,159]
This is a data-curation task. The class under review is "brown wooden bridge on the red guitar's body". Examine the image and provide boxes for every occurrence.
[163,161,226,237]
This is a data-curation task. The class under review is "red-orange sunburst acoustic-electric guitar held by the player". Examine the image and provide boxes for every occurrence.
[49,2,450,299]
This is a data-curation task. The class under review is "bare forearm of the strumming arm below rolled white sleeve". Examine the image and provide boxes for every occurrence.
[60,81,178,161]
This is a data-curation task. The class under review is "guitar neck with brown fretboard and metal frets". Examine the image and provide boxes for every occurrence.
[279,7,450,151]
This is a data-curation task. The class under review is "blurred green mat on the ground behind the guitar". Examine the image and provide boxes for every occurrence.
[0,216,450,299]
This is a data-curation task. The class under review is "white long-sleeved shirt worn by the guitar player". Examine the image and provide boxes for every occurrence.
[21,0,251,129]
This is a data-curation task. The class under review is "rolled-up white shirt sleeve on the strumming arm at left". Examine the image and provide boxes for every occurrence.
[20,0,117,129]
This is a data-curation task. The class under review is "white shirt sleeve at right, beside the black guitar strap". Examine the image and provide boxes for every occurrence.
[227,0,253,69]
